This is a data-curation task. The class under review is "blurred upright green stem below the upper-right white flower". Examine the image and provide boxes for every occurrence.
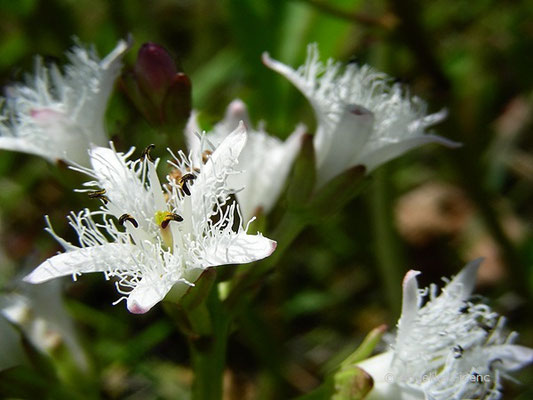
[370,166,403,314]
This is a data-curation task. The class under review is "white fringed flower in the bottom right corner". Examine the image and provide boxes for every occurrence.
[358,259,533,400]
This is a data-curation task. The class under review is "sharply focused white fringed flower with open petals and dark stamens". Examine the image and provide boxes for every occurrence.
[25,124,276,313]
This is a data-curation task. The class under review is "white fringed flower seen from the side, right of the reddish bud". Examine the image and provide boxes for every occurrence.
[263,44,457,186]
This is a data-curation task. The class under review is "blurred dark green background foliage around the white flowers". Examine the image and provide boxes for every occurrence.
[0,0,533,399]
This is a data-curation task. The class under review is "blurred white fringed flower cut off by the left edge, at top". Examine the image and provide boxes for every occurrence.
[0,40,128,165]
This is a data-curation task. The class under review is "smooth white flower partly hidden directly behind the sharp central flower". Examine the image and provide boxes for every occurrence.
[185,100,306,221]
